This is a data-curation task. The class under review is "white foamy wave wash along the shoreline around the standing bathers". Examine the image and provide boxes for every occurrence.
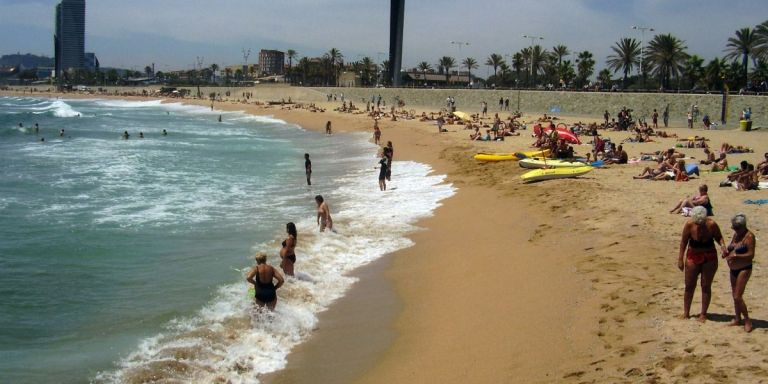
[95,157,454,383]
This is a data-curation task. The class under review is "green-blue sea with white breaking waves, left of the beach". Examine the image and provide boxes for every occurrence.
[0,97,455,384]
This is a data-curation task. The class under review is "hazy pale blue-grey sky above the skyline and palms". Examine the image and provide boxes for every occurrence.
[0,0,768,76]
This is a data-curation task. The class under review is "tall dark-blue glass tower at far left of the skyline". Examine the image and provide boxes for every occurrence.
[53,0,85,76]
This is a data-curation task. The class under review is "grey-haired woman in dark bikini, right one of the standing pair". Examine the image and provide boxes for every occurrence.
[723,213,755,332]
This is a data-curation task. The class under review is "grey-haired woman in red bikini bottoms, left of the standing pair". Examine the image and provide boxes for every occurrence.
[677,206,727,323]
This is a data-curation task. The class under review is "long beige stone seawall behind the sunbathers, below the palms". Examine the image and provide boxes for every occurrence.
[313,88,768,128]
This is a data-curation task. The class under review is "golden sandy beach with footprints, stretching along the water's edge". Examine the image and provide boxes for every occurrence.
[0,87,768,383]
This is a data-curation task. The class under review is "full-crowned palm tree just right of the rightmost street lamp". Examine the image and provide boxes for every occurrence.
[646,34,688,88]
